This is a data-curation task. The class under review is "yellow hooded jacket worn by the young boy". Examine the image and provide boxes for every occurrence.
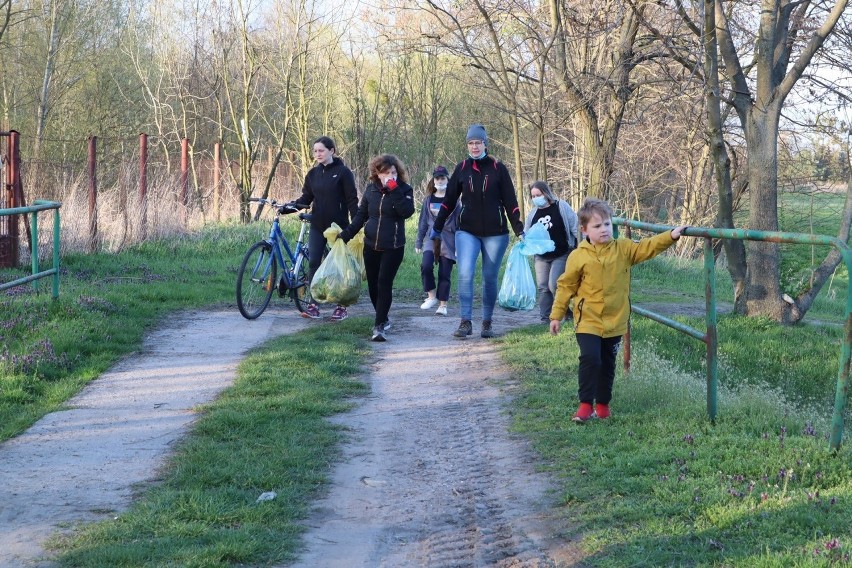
[550,231,675,337]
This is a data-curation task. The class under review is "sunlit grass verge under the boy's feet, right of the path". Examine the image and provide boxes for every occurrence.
[504,329,852,567]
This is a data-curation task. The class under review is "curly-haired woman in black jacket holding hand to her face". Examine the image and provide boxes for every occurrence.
[340,154,414,341]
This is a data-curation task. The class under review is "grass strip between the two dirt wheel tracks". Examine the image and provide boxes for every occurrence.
[52,318,369,568]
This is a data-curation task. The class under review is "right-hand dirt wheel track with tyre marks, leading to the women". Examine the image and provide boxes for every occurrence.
[288,310,580,568]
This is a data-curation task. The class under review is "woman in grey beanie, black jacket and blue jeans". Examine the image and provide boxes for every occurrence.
[430,124,524,338]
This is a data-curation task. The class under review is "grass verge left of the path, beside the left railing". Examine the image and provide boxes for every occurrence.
[0,225,259,441]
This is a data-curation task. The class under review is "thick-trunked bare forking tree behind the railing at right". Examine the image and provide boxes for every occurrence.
[715,0,847,322]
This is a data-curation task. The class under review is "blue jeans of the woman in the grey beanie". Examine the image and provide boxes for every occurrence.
[456,231,509,321]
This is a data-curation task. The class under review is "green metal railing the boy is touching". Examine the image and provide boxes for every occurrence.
[613,217,852,451]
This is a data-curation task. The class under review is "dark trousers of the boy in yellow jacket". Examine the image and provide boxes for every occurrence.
[577,333,621,404]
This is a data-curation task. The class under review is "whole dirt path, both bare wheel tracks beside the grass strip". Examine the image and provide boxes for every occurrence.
[0,300,576,567]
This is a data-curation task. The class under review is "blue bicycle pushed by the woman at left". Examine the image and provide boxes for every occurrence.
[237,197,313,319]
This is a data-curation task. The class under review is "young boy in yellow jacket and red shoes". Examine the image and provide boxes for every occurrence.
[550,198,686,422]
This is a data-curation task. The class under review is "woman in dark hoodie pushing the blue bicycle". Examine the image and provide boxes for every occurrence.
[296,136,358,320]
